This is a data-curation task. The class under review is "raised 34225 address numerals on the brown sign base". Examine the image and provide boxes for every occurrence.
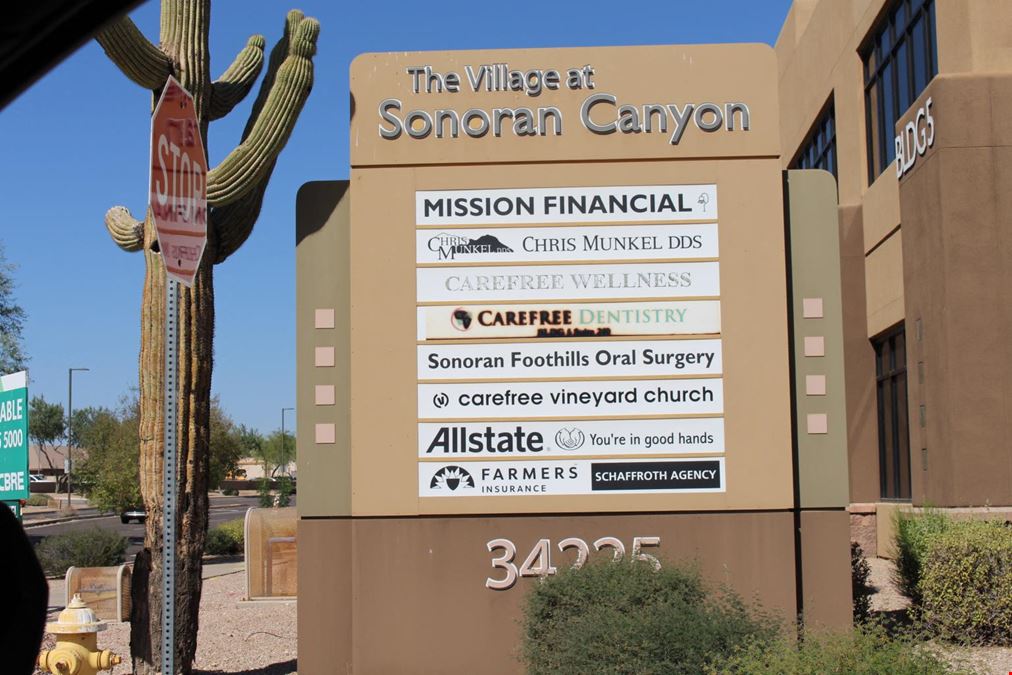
[485,536,661,591]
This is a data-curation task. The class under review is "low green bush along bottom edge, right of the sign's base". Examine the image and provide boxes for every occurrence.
[710,625,959,675]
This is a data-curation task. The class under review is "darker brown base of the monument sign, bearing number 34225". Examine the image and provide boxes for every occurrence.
[299,510,851,675]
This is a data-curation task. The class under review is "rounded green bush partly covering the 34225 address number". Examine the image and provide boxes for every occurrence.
[520,561,777,675]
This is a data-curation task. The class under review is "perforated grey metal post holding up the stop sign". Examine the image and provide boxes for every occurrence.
[162,277,179,675]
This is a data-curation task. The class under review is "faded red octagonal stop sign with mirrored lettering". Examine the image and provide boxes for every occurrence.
[148,75,207,286]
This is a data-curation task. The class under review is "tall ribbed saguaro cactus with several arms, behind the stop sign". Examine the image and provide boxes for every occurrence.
[97,0,320,675]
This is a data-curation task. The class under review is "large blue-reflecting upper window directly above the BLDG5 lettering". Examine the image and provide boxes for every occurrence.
[860,0,938,183]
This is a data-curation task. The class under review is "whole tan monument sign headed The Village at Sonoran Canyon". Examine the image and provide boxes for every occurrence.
[298,45,849,672]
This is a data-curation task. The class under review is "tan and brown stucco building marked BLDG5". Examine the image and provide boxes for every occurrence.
[776,0,1012,553]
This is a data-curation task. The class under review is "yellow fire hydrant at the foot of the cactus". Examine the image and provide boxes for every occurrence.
[38,594,122,675]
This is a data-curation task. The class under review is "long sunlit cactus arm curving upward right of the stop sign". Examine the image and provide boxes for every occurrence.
[206,13,320,206]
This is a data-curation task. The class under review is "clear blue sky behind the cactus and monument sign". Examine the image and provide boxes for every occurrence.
[0,0,790,431]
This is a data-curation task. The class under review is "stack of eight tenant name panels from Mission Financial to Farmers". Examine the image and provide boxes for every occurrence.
[415,184,726,498]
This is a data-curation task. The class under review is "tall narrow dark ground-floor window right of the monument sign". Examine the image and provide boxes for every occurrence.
[871,324,910,500]
